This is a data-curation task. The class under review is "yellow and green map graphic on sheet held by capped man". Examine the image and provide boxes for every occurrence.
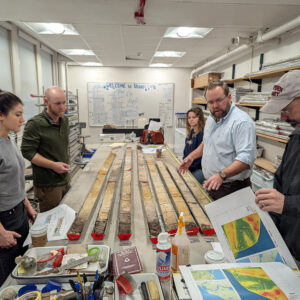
[222,213,280,260]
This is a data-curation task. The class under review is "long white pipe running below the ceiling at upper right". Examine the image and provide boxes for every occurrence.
[191,16,300,78]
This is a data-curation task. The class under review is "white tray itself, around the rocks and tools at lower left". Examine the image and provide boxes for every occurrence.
[11,245,110,284]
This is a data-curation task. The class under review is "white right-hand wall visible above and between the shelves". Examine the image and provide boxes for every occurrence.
[196,30,300,161]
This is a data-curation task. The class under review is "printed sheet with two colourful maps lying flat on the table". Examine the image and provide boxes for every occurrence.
[179,262,300,300]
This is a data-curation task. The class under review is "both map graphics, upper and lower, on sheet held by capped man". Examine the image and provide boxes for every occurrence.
[222,213,283,262]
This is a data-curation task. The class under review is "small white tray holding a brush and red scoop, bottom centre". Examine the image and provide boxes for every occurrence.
[115,273,165,300]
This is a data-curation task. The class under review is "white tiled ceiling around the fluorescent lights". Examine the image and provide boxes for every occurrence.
[4,0,300,67]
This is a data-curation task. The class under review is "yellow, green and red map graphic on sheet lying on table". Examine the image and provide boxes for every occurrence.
[223,267,288,300]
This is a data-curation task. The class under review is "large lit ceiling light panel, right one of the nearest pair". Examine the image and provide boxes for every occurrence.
[164,27,213,39]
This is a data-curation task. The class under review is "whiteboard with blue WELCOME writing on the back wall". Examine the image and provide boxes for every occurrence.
[87,82,174,127]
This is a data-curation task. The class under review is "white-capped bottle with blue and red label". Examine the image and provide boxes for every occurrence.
[156,232,171,280]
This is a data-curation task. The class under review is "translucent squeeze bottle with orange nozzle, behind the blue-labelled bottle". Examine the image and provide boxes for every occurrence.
[171,212,191,272]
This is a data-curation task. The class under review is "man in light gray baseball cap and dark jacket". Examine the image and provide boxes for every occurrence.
[255,70,300,268]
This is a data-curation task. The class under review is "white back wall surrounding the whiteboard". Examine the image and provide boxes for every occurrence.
[67,66,191,147]
